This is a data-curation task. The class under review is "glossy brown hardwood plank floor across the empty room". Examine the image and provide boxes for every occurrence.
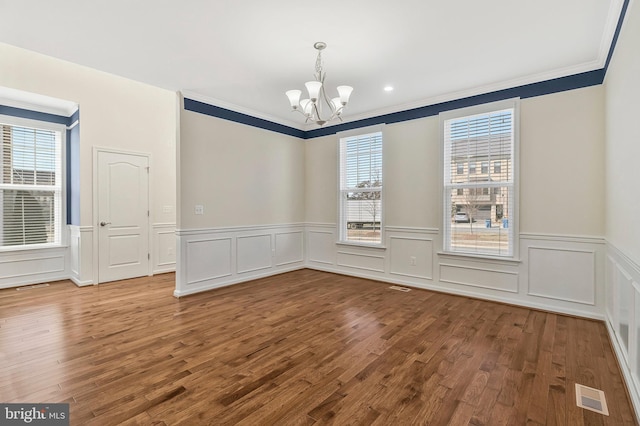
[0,270,636,426]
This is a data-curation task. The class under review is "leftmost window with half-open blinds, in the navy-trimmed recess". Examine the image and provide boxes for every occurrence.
[0,118,63,248]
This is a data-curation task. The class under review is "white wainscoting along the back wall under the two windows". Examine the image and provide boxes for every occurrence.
[305,223,605,319]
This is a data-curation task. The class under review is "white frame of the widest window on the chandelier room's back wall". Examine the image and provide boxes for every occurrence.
[439,98,520,261]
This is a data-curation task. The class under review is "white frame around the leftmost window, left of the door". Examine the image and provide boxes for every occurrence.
[0,115,67,252]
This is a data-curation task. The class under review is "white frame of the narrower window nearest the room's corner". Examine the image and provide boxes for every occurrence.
[336,125,385,248]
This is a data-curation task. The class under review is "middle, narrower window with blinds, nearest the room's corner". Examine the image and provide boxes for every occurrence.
[339,132,382,244]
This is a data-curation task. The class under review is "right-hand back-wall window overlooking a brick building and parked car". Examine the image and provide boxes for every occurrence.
[441,100,517,257]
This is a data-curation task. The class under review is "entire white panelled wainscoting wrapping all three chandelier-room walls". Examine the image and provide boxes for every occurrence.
[174,223,640,420]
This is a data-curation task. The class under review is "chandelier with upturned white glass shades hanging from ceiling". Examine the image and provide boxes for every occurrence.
[285,41,353,126]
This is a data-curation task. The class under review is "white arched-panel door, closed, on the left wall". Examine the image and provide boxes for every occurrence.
[97,151,149,283]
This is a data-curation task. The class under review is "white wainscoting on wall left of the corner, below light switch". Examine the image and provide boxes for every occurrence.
[174,224,305,297]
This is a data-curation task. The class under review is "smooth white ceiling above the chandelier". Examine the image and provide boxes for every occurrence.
[0,0,622,129]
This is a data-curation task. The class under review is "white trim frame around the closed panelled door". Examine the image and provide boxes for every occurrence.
[91,146,153,285]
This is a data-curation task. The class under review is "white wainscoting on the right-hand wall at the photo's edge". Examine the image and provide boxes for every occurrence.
[606,244,640,418]
